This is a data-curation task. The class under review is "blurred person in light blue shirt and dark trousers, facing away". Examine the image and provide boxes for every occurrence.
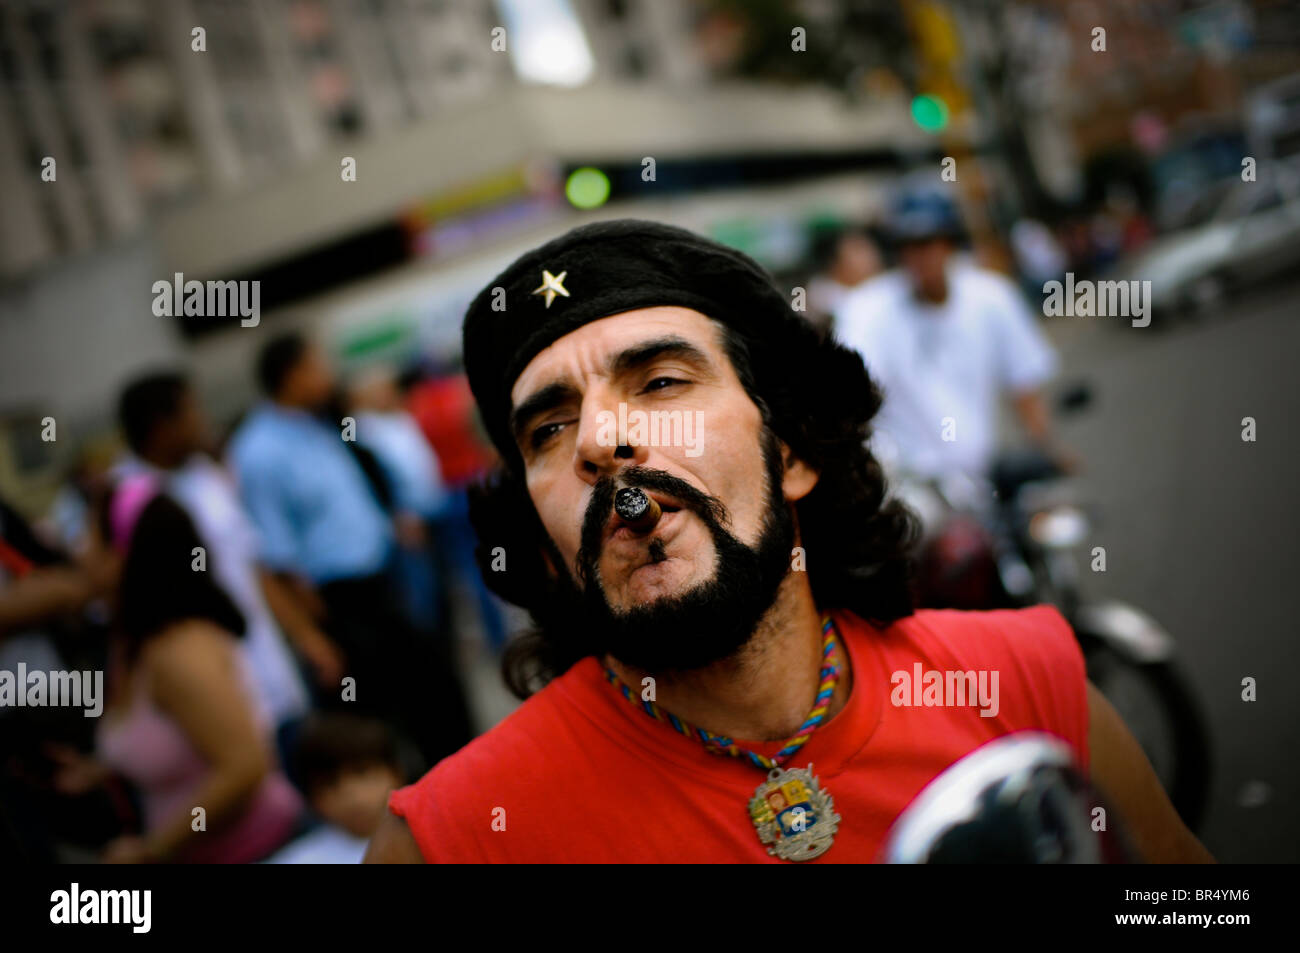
[229,334,473,764]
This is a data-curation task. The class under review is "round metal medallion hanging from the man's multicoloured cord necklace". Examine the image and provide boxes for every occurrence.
[749,764,840,861]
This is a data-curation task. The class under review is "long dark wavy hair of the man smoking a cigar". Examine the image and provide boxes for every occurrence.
[469,315,918,698]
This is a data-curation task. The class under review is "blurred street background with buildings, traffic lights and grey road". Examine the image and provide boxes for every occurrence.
[0,0,1300,862]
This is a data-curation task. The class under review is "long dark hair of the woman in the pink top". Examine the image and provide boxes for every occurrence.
[100,494,244,660]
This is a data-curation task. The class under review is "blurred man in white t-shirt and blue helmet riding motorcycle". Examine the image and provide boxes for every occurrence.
[835,190,1069,478]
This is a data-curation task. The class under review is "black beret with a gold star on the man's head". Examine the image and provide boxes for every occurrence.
[464,218,807,462]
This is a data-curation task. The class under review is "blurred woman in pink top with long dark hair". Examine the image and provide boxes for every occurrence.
[87,476,303,863]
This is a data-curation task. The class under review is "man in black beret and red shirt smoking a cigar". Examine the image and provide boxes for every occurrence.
[368,220,1208,863]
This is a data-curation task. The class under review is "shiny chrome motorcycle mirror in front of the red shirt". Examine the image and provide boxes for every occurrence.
[880,732,1132,863]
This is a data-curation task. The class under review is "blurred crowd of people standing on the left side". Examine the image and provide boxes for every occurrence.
[0,334,504,863]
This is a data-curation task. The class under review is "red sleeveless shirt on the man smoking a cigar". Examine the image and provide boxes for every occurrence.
[389,606,1088,863]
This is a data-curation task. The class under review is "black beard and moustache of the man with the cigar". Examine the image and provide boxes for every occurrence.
[546,428,794,673]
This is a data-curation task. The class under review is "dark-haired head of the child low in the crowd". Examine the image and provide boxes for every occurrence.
[294,714,403,837]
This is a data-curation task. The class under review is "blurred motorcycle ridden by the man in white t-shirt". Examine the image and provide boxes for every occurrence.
[896,387,1210,831]
